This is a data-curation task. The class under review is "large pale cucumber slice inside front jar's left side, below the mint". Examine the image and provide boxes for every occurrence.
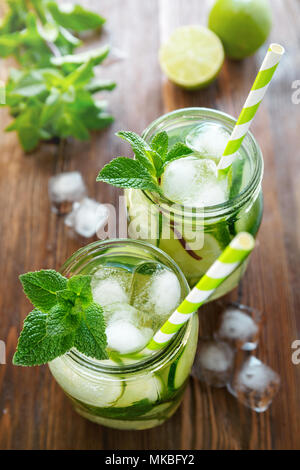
[49,357,125,408]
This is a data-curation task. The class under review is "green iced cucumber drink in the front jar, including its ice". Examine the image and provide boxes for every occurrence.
[49,240,198,429]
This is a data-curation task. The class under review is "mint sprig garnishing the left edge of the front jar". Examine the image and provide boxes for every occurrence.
[13,269,108,366]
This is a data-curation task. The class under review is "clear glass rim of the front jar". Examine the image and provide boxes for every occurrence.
[60,238,192,375]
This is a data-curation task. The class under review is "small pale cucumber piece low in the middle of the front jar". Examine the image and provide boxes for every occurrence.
[115,374,164,407]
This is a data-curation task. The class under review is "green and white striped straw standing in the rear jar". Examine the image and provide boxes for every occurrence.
[218,44,284,170]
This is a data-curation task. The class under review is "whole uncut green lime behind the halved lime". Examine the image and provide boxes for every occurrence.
[208,0,272,59]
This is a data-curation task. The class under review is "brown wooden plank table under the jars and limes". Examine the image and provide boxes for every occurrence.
[0,0,300,449]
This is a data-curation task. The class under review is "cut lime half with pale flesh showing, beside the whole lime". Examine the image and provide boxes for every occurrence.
[159,26,224,89]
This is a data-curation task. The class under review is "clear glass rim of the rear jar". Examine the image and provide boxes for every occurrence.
[142,107,264,219]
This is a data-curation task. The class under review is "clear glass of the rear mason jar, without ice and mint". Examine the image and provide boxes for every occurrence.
[125,108,263,300]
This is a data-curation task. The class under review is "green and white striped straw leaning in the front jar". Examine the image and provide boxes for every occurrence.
[143,232,255,353]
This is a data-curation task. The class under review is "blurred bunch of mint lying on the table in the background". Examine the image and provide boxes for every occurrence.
[0,0,115,152]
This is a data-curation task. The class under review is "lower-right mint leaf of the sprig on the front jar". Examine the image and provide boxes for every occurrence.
[75,303,108,360]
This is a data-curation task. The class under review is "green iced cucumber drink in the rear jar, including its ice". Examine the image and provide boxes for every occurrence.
[125,108,263,298]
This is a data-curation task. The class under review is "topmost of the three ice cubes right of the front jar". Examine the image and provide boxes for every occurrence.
[215,305,260,351]
